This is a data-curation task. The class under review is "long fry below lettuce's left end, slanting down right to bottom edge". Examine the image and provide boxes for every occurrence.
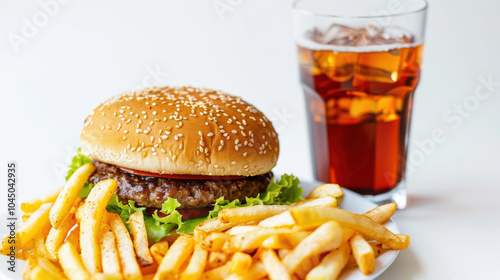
[108,212,142,280]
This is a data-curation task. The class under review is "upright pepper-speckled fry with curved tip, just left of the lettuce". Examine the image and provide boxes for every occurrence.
[81,179,118,275]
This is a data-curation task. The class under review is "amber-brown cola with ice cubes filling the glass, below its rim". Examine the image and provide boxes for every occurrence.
[298,24,423,195]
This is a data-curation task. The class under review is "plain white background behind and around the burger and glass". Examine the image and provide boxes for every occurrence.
[0,0,500,280]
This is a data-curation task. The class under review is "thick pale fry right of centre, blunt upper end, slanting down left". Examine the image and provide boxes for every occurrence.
[283,221,343,275]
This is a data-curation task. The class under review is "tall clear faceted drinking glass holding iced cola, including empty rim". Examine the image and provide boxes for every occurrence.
[293,0,427,209]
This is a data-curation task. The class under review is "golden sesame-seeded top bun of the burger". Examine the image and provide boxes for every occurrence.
[80,87,279,176]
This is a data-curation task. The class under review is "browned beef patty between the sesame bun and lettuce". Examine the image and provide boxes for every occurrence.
[89,161,273,209]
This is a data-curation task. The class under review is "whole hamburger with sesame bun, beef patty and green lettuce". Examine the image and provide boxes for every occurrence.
[68,87,302,242]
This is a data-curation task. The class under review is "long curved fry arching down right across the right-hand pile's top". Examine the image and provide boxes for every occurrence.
[291,206,408,250]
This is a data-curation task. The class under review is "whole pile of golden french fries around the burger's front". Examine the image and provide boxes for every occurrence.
[4,173,410,280]
